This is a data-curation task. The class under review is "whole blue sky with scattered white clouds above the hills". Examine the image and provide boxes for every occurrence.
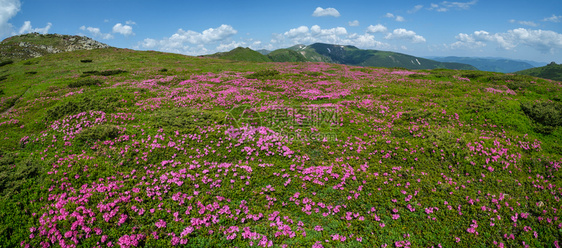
[0,0,562,63]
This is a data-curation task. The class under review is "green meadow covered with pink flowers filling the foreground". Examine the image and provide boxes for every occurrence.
[0,48,562,247]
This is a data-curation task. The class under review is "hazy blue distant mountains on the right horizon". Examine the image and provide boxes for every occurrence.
[429,56,534,73]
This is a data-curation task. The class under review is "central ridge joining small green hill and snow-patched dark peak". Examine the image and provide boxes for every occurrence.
[206,43,477,70]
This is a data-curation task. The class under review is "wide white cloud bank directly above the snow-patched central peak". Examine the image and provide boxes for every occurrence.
[271,25,390,49]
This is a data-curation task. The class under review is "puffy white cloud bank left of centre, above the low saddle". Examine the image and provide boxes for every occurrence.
[135,24,237,55]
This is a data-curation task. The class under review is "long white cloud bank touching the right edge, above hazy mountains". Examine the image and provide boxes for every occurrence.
[451,28,562,53]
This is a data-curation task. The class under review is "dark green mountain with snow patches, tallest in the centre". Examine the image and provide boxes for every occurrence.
[289,43,476,70]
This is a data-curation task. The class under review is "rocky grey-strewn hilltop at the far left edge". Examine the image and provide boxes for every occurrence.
[0,33,109,61]
